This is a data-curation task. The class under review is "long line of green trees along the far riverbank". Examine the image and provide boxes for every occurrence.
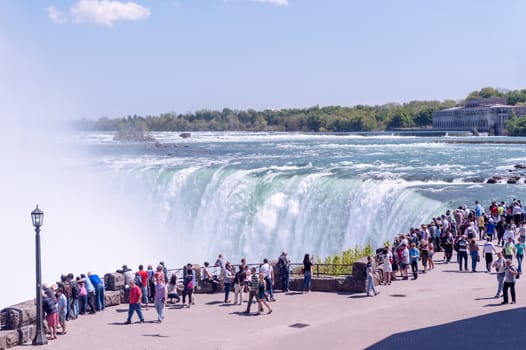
[74,88,526,133]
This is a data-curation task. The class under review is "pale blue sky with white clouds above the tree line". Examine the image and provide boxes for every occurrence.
[0,0,526,119]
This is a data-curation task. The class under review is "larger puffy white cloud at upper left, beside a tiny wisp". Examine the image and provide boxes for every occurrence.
[70,0,150,27]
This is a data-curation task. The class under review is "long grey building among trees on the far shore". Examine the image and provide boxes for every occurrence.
[433,98,526,135]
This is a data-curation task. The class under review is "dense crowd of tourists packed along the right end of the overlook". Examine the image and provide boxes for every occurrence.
[367,199,526,304]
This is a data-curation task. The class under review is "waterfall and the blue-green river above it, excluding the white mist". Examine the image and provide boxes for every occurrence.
[80,133,526,264]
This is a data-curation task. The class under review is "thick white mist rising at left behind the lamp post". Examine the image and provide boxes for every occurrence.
[0,120,164,308]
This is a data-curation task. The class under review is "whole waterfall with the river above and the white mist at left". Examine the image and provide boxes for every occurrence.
[0,132,526,306]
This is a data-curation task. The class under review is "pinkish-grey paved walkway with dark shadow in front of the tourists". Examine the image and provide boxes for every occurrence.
[42,253,526,350]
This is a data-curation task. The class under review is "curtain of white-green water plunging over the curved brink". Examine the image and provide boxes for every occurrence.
[112,166,444,264]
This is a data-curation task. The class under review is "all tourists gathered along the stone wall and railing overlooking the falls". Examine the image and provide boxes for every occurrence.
[42,200,526,339]
